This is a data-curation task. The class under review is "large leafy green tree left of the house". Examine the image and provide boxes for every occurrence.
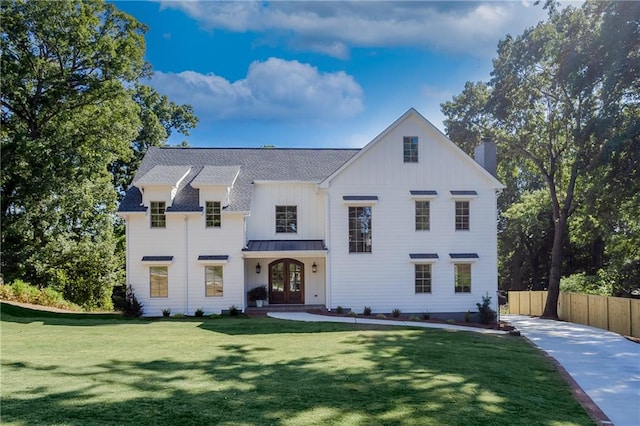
[0,0,149,307]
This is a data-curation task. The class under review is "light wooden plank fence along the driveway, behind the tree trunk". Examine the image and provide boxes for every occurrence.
[509,291,640,337]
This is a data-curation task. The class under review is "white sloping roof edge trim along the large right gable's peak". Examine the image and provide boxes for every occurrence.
[321,108,505,189]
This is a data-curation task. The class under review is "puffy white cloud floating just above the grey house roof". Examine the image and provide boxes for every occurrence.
[147,58,363,121]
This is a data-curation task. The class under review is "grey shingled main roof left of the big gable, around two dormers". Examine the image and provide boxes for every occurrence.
[119,147,359,212]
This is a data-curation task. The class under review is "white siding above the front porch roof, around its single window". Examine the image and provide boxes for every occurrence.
[247,182,325,240]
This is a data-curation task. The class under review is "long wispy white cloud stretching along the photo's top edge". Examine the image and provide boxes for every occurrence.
[162,1,546,59]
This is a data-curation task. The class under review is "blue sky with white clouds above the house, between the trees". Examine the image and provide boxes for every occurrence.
[114,1,568,148]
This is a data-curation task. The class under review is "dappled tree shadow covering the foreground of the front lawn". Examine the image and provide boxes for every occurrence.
[2,330,591,425]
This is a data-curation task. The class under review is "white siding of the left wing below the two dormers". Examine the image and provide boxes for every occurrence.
[127,207,244,316]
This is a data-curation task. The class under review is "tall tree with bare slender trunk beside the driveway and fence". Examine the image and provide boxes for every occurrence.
[490,1,640,318]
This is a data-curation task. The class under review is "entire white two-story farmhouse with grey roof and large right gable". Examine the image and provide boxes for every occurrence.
[119,109,503,318]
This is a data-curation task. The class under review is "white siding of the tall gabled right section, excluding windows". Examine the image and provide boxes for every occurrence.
[328,113,497,313]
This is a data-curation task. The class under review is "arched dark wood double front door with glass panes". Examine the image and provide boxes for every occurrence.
[269,259,304,304]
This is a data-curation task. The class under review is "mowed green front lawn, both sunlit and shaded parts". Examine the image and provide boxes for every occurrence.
[1,305,593,426]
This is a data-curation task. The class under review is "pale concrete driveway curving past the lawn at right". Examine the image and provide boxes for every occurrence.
[500,315,640,426]
